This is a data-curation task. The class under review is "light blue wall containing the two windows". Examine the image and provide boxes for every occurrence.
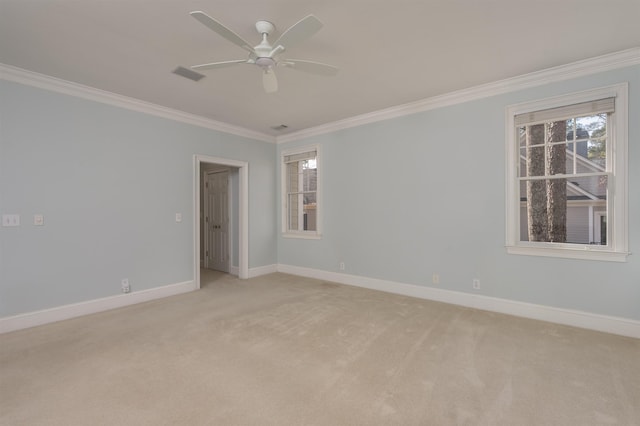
[278,66,640,320]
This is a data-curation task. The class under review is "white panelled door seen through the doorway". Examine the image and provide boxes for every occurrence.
[204,170,229,272]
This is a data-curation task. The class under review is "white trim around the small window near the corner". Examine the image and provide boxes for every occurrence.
[280,145,323,240]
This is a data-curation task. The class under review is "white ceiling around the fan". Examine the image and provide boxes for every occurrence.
[0,0,640,135]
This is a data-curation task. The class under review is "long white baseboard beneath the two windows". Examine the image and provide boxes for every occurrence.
[278,265,640,339]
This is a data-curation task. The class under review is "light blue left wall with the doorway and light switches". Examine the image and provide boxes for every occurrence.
[0,81,277,317]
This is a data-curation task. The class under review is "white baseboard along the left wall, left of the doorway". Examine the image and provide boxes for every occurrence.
[0,281,196,334]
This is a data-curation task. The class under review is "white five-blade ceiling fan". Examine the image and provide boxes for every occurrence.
[191,11,338,93]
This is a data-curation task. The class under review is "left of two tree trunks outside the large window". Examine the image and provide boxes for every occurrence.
[525,124,547,241]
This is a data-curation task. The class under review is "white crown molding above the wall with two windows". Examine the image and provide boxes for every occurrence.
[276,47,640,144]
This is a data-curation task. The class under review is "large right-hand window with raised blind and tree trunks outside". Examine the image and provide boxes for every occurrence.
[506,84,628,261]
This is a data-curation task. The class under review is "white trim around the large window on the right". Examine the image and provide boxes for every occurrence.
[505,83,630,262]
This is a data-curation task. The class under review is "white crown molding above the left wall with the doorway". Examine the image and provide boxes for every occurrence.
[0,63,276,143]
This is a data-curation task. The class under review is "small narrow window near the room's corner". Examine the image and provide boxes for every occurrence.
[282,146,320,238]
